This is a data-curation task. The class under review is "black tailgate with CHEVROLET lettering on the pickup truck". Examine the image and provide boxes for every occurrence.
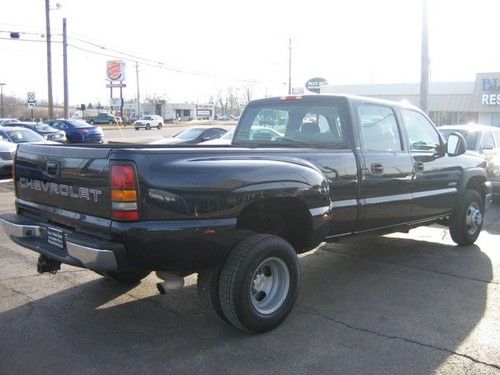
[15,144,111,218]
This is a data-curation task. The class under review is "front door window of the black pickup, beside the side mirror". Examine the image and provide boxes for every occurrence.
[401,109,441,151]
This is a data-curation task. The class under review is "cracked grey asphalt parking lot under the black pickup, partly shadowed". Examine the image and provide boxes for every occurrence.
[0,183,500,374]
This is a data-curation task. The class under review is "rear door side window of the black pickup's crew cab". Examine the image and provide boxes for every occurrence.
[358,104,402,152]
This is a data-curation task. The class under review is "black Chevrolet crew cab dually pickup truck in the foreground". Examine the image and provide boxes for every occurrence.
[1,95,491,332]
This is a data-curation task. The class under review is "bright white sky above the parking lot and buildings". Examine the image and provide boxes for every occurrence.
[0,0,500,106]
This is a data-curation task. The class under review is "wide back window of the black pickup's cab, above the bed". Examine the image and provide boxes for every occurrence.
[233,101,346,148]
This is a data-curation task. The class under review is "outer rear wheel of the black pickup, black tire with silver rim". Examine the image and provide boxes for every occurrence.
[219,234,300,333]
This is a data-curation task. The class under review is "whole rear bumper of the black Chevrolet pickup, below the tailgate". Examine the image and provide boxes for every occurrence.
[0,214,126,271]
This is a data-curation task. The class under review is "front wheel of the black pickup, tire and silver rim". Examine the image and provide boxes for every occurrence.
[450,190,484,246]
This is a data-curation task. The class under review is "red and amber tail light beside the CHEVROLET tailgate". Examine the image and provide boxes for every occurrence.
[111,164,139,221]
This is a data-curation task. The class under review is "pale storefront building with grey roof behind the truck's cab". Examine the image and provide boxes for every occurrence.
[321,73,500,127]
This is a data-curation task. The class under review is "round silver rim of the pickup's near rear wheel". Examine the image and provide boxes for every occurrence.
[250,257,290,315]
